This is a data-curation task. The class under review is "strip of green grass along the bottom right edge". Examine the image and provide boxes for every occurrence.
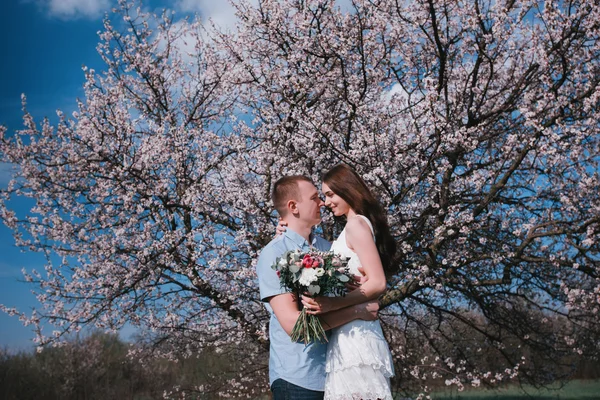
[431,380,600,400]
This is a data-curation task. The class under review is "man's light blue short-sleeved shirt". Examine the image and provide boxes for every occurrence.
[256,228,331,391]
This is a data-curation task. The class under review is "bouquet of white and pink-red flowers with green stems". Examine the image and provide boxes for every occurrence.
[272,250,352,343]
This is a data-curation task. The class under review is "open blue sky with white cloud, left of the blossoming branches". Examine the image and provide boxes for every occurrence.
[0,0,246,349]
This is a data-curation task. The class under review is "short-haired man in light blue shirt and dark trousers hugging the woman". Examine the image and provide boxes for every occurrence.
[257,175,378,400]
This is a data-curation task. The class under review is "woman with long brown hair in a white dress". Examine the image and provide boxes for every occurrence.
[302,164,396,400]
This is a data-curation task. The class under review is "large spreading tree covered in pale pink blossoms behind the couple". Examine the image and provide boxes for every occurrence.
[0,0,600,394]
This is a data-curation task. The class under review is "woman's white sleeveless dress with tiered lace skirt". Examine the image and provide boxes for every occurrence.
[325,215,394,400]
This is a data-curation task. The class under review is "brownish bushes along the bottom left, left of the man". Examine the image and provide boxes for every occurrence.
[0,333,256,400]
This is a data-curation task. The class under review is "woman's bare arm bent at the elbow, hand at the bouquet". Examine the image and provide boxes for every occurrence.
[302,217,386,314]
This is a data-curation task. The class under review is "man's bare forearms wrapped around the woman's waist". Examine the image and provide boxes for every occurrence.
[269,293,379,335]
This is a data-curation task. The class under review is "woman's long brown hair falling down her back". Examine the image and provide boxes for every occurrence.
[323,164,398,277]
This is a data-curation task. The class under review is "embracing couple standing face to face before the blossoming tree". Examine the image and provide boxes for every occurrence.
[257,164,395,400]
